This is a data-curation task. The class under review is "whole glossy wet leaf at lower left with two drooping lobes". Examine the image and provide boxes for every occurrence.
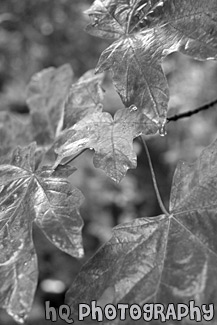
[0,143,83,322]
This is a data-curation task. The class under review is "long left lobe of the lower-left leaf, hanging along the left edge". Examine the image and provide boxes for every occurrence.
[0,191,38,323]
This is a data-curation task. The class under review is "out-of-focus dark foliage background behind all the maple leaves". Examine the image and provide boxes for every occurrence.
[0,0,217,325]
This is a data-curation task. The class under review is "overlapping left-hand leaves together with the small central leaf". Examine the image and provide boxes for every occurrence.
[0,58,157,322]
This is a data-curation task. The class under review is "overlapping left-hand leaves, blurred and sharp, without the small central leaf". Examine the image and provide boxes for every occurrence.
[0,65,108,322]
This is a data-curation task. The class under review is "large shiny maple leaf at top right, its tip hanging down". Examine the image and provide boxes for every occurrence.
[87,0,217,127]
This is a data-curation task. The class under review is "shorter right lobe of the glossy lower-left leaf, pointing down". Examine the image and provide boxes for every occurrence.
[35,168,83,257]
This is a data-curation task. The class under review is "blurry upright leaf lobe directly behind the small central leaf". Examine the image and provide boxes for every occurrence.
[59,70,104,130]
